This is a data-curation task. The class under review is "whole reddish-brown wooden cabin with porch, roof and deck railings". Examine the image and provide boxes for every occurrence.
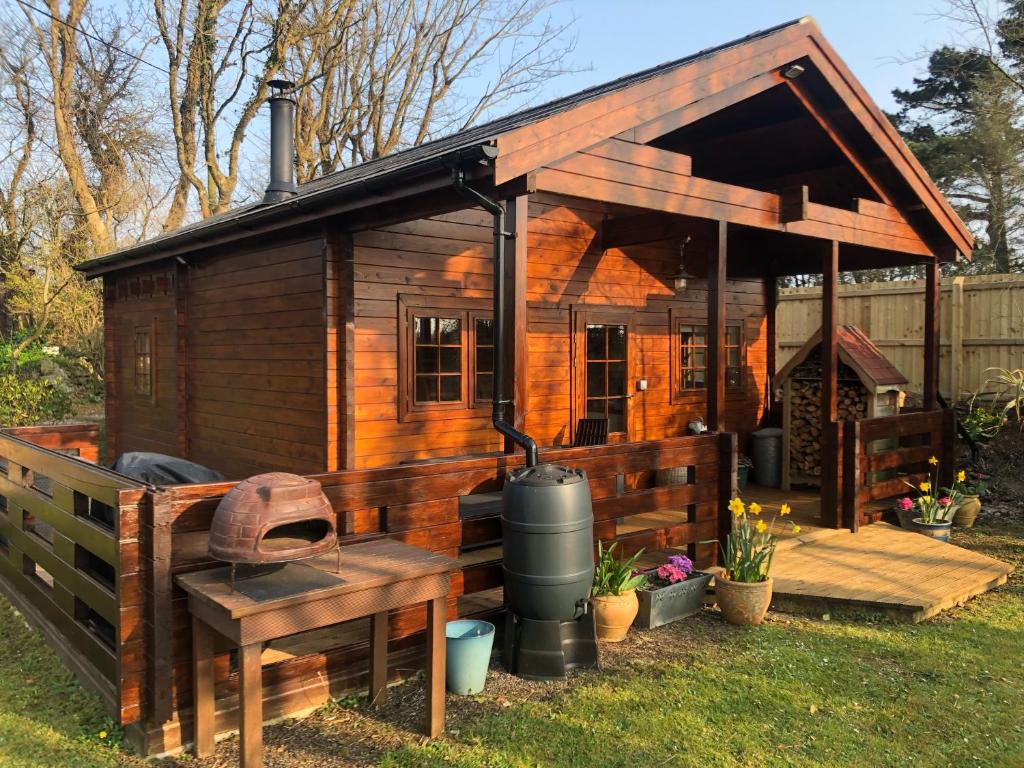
[36,18,972,754]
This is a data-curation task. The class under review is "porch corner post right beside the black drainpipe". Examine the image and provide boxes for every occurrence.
[504,195,529,454]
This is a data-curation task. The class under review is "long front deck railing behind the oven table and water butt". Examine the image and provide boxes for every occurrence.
[132,434,735,753]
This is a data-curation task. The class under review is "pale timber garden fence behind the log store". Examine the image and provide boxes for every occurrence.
[776,274,1024,397]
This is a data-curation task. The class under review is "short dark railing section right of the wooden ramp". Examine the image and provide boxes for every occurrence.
[837,410,955,529]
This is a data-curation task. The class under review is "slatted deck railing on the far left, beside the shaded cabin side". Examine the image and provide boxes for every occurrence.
[0,434,145,723]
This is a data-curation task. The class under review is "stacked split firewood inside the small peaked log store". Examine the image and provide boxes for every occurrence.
[790,360,867,477]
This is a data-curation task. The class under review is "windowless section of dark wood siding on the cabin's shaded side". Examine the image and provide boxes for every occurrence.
[186,237,326,478]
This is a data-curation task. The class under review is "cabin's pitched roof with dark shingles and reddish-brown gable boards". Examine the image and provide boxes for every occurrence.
[76,16,971,276]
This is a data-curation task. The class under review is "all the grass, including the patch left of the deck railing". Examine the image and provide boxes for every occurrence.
[0,525,1024,768]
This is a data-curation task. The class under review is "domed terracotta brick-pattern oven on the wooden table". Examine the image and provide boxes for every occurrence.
[210,472,338,564]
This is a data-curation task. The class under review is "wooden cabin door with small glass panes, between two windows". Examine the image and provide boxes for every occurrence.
[571,311,634,442]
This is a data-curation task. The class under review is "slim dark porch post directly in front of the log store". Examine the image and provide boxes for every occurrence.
[821,241,841,528]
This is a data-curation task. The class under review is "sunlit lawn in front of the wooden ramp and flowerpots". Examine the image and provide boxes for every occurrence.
[381,528,1024,768]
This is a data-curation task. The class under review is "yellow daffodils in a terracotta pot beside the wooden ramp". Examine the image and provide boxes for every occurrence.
[715,497,800,625]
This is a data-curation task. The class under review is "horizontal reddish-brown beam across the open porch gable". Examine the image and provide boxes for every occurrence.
[537,151,933,258]
